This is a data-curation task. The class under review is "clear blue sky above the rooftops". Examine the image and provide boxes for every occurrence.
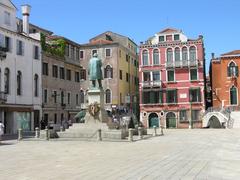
[12,0,240,72]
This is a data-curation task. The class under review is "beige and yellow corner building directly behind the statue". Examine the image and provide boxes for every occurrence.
[80,31,138,114]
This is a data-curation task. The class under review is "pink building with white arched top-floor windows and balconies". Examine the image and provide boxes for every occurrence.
[139,28,205,128]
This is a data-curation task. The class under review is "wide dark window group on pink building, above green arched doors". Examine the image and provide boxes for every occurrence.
[142,91,163,104]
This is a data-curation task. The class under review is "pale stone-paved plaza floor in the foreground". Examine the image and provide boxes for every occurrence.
[0,129,240,180]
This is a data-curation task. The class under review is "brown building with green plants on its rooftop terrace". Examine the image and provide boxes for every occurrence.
[41,35,81,129]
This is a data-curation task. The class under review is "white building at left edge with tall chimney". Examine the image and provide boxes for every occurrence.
[0,0,42,134]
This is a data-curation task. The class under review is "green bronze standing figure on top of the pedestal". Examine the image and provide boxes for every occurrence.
[88,53,103,88]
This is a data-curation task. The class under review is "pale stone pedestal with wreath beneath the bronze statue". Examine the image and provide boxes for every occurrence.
[84,88,108,124]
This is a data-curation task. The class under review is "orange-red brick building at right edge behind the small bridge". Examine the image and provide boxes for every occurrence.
[210,50,240,110]
